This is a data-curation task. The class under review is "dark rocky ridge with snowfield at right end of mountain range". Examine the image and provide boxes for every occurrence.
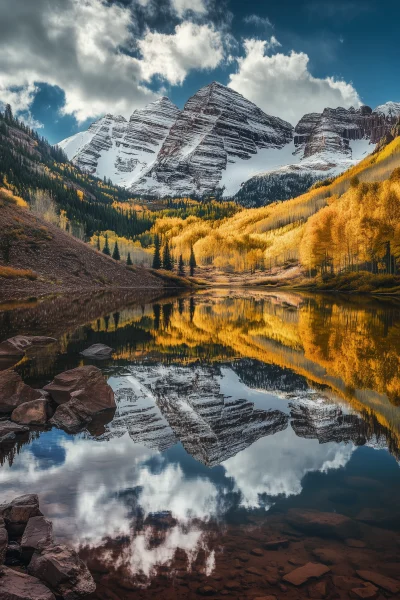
[236,102,400,208]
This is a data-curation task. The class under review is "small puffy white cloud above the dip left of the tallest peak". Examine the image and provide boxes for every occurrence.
[138,21,224,85]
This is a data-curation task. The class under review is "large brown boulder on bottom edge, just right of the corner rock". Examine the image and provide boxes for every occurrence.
[28,545,96,600]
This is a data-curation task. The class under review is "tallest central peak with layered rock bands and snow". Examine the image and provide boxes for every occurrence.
[132,82,293,196]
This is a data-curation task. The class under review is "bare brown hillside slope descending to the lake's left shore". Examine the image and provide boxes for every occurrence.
[0,190,163,301]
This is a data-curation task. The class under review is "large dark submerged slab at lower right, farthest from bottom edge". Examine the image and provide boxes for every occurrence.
[287,509,359,540]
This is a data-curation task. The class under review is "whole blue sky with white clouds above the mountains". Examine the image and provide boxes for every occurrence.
[0,0,400,143]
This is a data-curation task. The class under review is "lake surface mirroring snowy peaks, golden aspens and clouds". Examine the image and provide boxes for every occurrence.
[0,291,400,599]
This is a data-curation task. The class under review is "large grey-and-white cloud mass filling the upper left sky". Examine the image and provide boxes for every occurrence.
[0,0,223,121]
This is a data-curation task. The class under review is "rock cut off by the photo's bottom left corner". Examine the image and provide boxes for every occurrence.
[0,567,55,600]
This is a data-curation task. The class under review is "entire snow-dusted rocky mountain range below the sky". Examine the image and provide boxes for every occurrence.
[59,82,400,207]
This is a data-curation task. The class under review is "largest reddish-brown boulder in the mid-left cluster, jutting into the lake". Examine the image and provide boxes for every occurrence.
[45,366,116,433]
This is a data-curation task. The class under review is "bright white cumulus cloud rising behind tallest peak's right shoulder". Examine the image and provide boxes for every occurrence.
[229,38,361,125]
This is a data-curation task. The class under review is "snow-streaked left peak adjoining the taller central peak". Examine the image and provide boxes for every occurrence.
[58,97,180,188]
